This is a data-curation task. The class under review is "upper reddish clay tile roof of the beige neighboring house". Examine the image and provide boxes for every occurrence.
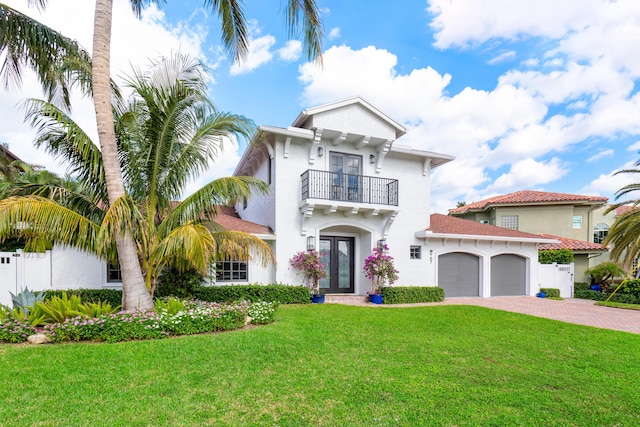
[449,190,609,214]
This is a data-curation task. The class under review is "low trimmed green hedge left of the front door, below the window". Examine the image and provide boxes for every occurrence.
[195,284,311,304]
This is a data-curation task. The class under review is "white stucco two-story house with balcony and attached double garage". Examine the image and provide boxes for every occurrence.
[0,97,557,303]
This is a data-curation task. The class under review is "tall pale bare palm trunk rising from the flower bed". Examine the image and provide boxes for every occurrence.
[92,0,153,310]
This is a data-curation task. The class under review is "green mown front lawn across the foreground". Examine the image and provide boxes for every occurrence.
[0,304,640,426]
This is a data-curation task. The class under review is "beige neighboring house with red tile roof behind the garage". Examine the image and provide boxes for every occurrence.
[449,190,612,281]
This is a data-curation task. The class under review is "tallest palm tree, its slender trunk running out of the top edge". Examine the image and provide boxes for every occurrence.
[0,0,323,309]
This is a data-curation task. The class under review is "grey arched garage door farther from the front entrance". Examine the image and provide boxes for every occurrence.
[491,254,527,297]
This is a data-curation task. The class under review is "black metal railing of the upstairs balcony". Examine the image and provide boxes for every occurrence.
[301,170,398,206]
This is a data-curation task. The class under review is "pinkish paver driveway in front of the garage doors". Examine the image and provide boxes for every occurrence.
[360,296,640,334]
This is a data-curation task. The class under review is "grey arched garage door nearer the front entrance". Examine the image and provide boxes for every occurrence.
[438,252,480,298]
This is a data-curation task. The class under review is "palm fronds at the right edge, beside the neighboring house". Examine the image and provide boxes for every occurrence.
[603,161,640,266]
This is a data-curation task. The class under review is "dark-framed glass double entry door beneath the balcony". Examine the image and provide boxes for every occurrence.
[320,236,355,294]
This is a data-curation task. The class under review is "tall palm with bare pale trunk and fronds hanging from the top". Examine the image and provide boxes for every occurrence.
[0,0,323,309]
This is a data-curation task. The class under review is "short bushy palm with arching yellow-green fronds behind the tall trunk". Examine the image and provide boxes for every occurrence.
[0,54,273,309]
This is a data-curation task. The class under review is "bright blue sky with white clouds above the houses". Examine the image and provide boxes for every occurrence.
[0,0,640,212]
